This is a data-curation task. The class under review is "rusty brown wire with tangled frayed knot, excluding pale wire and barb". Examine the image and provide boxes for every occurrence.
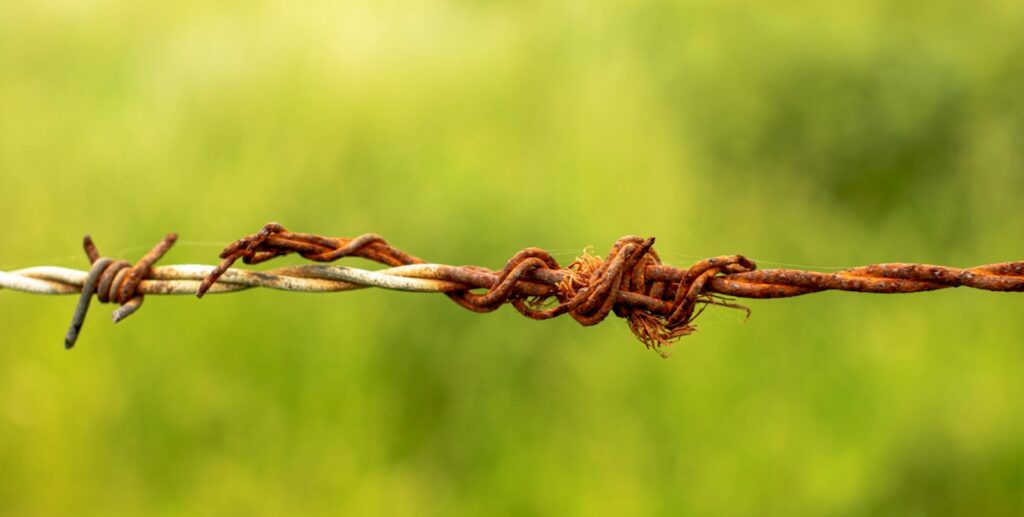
[197,223,1024,354]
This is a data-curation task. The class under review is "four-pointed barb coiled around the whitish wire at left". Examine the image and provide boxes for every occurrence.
[65,233,178,349]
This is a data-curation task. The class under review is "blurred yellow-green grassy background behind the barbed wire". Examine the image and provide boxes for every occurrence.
[0,0,1024,516]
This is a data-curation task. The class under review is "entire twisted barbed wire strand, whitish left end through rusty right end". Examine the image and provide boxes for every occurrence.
[0,223,1024,354]
